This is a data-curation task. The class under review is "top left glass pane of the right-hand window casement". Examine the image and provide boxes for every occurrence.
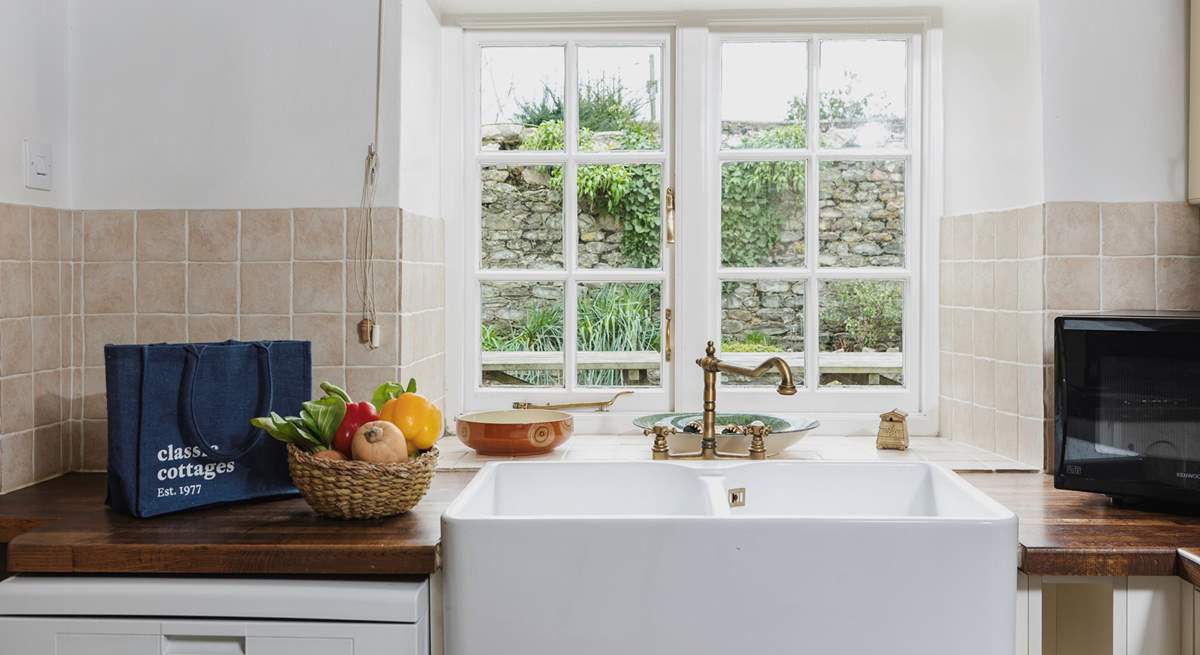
[721,42,809,149]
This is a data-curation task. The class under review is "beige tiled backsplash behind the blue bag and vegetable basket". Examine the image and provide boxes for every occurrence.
[0,205,445,491]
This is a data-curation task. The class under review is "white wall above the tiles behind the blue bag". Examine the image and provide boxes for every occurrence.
[66,0,403,209]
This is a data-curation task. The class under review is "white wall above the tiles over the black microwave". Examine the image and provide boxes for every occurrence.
[1042,0,1188,202]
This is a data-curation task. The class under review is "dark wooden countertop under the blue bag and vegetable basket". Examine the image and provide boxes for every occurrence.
[0,471,473,576]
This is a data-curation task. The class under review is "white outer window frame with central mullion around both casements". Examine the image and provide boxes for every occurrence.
[442,10,942,434]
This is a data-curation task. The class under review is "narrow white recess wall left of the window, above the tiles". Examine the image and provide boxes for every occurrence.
[400,0,442,216]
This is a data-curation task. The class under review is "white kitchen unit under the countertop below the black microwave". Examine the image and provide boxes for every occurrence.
[1016,573,1200,655]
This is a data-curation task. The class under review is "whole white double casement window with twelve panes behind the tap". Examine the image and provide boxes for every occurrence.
[449,19,936,432]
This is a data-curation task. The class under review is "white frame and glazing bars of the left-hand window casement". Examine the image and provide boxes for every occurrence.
[458,30,673,411]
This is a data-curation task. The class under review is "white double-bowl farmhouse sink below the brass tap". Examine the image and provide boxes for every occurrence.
[442,461,1016,655]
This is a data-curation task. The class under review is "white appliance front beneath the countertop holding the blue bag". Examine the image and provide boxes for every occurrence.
[0,576,430,655]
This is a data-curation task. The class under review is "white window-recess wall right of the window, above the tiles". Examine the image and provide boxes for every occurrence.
[943,0,1044,216]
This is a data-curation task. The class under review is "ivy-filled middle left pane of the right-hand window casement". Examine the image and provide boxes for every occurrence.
[721,162,805,266]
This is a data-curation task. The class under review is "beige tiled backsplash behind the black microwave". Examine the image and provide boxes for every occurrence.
[940,203,1200,464]
